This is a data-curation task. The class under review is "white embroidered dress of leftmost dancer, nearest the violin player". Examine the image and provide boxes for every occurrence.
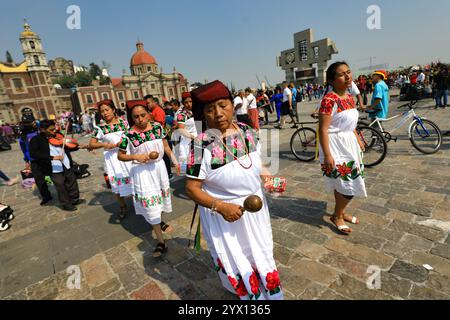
[92,118,132,197]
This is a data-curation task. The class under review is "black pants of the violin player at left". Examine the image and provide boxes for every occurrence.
[52,168,80,207]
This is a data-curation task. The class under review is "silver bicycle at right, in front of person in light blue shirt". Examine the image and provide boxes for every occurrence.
[360,100,442,154]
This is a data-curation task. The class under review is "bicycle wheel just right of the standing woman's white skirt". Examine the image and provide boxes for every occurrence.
[356,126,387,168]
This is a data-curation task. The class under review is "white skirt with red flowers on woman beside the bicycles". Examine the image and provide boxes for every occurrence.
[319,131,367,197]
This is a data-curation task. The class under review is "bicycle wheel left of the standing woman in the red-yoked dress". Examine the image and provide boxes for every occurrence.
[291,128,317,162]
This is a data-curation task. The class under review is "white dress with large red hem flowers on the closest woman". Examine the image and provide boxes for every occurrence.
[187,124,283,300]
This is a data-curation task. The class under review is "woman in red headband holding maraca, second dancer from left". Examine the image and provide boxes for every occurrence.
[118,101,178,257]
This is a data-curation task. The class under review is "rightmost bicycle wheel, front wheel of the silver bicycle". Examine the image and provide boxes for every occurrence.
[409,119,442,154]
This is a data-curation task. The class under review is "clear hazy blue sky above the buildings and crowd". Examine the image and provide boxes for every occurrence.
[0,0,450,87]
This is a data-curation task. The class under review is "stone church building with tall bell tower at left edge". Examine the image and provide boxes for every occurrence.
[0,22,62,123]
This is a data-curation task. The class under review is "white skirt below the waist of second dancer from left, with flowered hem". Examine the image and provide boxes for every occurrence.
[131,160,172,225]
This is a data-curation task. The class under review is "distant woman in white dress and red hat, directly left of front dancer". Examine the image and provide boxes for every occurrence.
[174,92,197,168]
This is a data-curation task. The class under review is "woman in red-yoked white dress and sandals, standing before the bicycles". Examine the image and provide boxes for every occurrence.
[319,62,367,234]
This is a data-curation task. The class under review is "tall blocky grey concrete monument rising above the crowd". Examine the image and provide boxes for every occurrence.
[277,29,338,84]
